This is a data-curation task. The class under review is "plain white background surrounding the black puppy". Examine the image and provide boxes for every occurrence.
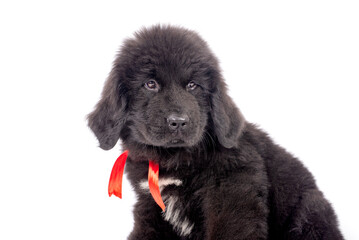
[0,0,359,239]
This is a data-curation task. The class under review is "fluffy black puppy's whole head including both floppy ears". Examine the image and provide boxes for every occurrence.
[88,26,244,153]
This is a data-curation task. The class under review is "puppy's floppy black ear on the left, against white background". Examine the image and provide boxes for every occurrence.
[87,66,127,150]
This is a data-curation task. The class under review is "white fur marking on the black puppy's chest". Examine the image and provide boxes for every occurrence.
[139,178,194,236]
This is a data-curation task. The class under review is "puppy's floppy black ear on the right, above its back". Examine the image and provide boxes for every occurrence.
[211,81,245,148]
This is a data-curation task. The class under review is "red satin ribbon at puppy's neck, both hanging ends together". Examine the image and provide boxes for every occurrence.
[108,150,166,211]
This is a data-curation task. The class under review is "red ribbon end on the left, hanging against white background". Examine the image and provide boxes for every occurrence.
[108,150,128,198]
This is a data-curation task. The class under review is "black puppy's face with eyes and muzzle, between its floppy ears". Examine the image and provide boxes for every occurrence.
[128,54,211,147]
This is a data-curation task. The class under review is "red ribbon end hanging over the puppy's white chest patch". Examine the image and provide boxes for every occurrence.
[148,160,166,211]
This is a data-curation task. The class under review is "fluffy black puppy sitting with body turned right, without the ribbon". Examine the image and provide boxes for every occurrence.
[88,26,343,240]
